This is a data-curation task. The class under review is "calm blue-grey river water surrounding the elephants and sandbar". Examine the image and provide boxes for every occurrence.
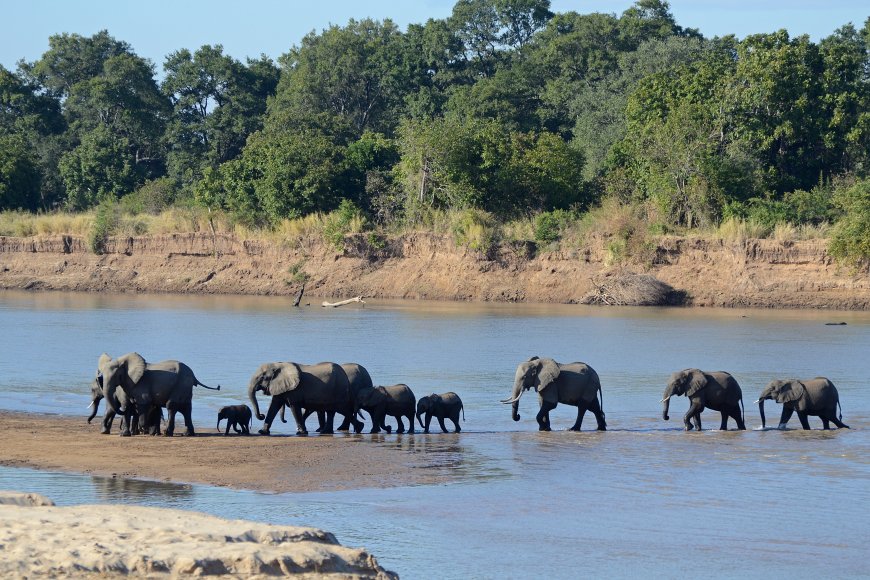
[0,292,870,578]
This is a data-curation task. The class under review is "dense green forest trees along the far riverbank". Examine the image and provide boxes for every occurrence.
[0,0,870,260]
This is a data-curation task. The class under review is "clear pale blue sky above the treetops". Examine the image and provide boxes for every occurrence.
[0,0,870,71]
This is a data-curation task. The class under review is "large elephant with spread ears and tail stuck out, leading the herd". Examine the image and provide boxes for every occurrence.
[97,352,220,437]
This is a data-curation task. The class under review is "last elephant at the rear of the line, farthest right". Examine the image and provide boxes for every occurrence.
[755,377,849,429]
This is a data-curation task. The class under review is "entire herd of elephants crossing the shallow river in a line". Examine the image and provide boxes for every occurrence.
[88,353,849,436]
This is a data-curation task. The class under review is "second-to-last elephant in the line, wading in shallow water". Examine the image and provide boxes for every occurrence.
[661,369,746,431]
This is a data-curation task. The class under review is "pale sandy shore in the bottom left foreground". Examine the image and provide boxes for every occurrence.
[0,491,397,580]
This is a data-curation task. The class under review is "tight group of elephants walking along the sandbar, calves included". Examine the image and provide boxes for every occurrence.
[88,352,465,436]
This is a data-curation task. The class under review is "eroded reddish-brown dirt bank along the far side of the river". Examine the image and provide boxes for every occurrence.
[0,233,870,310]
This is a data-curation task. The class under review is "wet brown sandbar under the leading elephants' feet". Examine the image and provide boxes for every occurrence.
[0,411,449,492]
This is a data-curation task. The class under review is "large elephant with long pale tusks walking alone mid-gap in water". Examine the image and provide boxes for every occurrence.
[502,356,607,431]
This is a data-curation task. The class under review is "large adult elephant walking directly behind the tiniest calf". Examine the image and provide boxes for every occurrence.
[248,362,353,435]
